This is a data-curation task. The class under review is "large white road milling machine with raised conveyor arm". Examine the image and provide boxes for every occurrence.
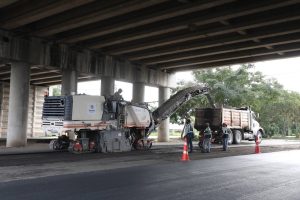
[42,85,209,153]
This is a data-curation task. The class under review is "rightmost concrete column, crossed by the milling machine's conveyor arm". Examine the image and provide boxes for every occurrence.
[157,87,170,142]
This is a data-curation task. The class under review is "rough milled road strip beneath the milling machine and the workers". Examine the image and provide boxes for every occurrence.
[0,140,300,182]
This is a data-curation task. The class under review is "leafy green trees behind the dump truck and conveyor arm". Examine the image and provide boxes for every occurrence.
[171,64,300,136]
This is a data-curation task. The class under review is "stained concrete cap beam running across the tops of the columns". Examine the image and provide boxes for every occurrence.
[0,30,172,86]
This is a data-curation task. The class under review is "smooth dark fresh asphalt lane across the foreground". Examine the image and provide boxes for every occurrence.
[0,150,300,200]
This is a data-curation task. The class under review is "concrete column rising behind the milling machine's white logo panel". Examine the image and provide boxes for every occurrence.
[61,69,78,96]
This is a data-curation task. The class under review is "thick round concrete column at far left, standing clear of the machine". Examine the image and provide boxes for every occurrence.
[6,62,30,147]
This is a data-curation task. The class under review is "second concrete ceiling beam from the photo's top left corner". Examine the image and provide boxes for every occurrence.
[35,0,168,36]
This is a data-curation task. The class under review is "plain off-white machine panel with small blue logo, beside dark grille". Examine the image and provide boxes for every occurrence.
[72,95,105,121]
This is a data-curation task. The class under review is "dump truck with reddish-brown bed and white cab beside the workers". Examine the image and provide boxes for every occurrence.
[194,107,264,144]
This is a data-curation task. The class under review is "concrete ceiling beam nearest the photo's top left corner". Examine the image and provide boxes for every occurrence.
[0,0,95,29]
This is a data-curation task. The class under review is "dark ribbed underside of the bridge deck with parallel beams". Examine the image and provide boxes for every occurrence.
[0,0,300,85]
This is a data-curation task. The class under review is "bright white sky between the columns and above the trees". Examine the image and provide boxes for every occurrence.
[74,57,300,102]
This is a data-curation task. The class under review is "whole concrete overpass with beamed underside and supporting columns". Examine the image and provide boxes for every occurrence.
[0,0,300,146]
